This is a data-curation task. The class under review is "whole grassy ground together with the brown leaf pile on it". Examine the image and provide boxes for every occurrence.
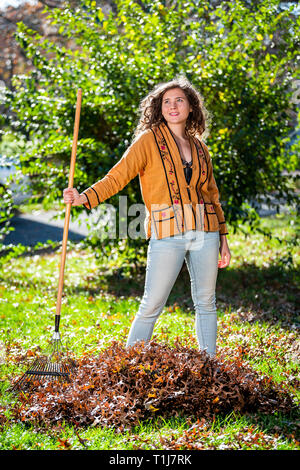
[0,212,300,450]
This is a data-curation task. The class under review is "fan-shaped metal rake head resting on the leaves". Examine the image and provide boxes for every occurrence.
[12,332,76,391]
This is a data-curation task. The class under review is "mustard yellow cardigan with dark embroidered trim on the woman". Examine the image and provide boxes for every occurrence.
[83,123,228,239]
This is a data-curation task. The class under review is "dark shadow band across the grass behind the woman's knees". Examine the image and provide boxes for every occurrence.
[75,264,300,328]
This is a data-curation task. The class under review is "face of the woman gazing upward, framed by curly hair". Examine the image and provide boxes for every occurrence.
[161,88,192,124]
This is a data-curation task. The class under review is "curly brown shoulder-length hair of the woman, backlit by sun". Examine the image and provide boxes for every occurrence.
[133,76,211,140]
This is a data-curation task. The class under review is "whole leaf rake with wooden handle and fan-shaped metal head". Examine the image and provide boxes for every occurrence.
[12,88,82,390]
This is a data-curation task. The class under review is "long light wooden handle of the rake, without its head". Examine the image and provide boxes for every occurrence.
[55,88,82,333]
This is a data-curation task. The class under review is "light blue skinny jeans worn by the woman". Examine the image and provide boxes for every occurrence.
[126,230,220,356]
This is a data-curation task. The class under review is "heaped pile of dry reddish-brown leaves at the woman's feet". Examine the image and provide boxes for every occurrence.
[12,341,295,429]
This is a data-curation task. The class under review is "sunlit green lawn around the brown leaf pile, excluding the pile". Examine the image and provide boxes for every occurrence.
[0,211,299,450]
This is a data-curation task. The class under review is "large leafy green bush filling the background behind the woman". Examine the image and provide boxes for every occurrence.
[0,0,299,258]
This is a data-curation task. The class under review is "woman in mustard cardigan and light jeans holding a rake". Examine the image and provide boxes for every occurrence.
[64,78,231,356]
